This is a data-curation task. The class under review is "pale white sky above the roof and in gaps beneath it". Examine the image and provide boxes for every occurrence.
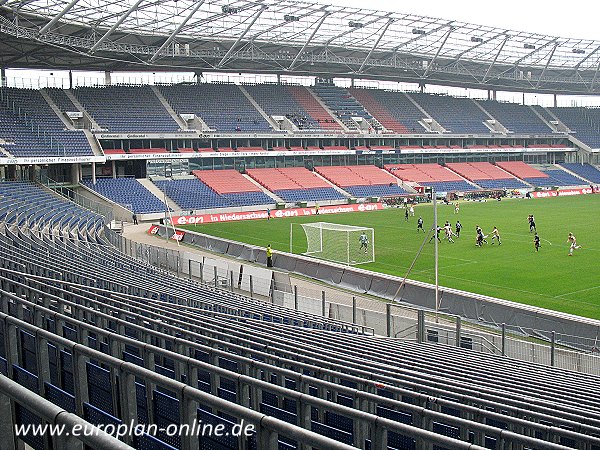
[8,0,600,106]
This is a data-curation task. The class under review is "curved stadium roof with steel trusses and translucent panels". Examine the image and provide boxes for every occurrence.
[0,0,600,94]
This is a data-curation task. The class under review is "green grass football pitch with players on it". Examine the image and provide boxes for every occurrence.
[182,195,600,319]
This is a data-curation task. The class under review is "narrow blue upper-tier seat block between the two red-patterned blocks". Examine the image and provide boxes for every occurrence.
[312,84,381,130]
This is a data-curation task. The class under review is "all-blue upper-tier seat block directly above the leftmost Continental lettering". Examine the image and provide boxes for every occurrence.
[73,86,180,133]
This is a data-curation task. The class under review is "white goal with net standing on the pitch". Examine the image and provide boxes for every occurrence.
[301,222,375,265]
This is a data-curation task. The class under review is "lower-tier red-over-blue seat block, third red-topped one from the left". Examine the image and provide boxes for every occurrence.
[315,166,408,197]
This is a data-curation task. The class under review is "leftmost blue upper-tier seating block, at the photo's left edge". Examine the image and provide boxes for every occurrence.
[0,88,93,157]
